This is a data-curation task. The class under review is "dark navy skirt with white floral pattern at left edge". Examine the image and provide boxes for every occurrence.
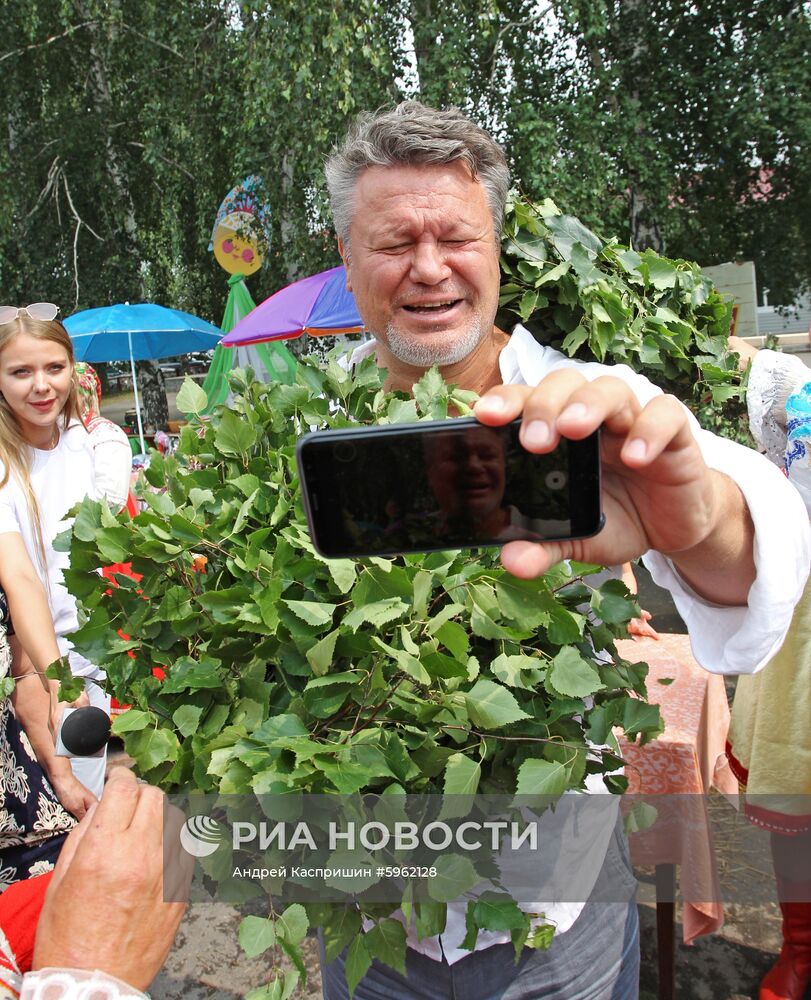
[0,591,76,892]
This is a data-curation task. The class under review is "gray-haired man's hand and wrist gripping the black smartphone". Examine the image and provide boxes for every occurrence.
[475,369,755,605]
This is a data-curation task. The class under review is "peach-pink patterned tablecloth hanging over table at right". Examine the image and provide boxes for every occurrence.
[617,635,738,944]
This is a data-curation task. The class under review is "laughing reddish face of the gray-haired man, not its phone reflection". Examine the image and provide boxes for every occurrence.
[339,161,499,368]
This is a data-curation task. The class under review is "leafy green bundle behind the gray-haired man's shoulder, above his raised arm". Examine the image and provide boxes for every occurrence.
[499,197,751,443]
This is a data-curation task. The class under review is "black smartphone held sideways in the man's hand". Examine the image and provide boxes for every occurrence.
[296,418,603,559]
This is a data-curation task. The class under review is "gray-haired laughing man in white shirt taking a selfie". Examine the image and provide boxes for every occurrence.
[323,101,810,1000]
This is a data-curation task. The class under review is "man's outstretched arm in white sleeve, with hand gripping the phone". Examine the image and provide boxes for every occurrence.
[476,365,811,673]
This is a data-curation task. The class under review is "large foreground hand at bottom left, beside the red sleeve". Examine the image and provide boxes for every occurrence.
[33,767,194,990]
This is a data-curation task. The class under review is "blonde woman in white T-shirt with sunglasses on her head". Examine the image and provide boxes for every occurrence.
[0,302,109,796]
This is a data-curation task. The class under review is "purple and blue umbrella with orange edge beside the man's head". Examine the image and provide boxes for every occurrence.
[222,267,363,347]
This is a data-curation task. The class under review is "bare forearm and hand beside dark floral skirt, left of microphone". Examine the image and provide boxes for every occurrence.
[11,637,96,819]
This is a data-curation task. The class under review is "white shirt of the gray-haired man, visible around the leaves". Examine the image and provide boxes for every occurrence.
[351,326,811,965]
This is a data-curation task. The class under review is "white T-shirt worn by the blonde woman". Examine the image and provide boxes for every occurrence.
[0,421,95,651]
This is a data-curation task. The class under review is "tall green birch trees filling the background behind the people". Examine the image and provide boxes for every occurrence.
[0,0,811,320]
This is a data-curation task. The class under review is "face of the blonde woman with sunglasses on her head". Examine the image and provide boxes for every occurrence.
[0,333,73,448]
